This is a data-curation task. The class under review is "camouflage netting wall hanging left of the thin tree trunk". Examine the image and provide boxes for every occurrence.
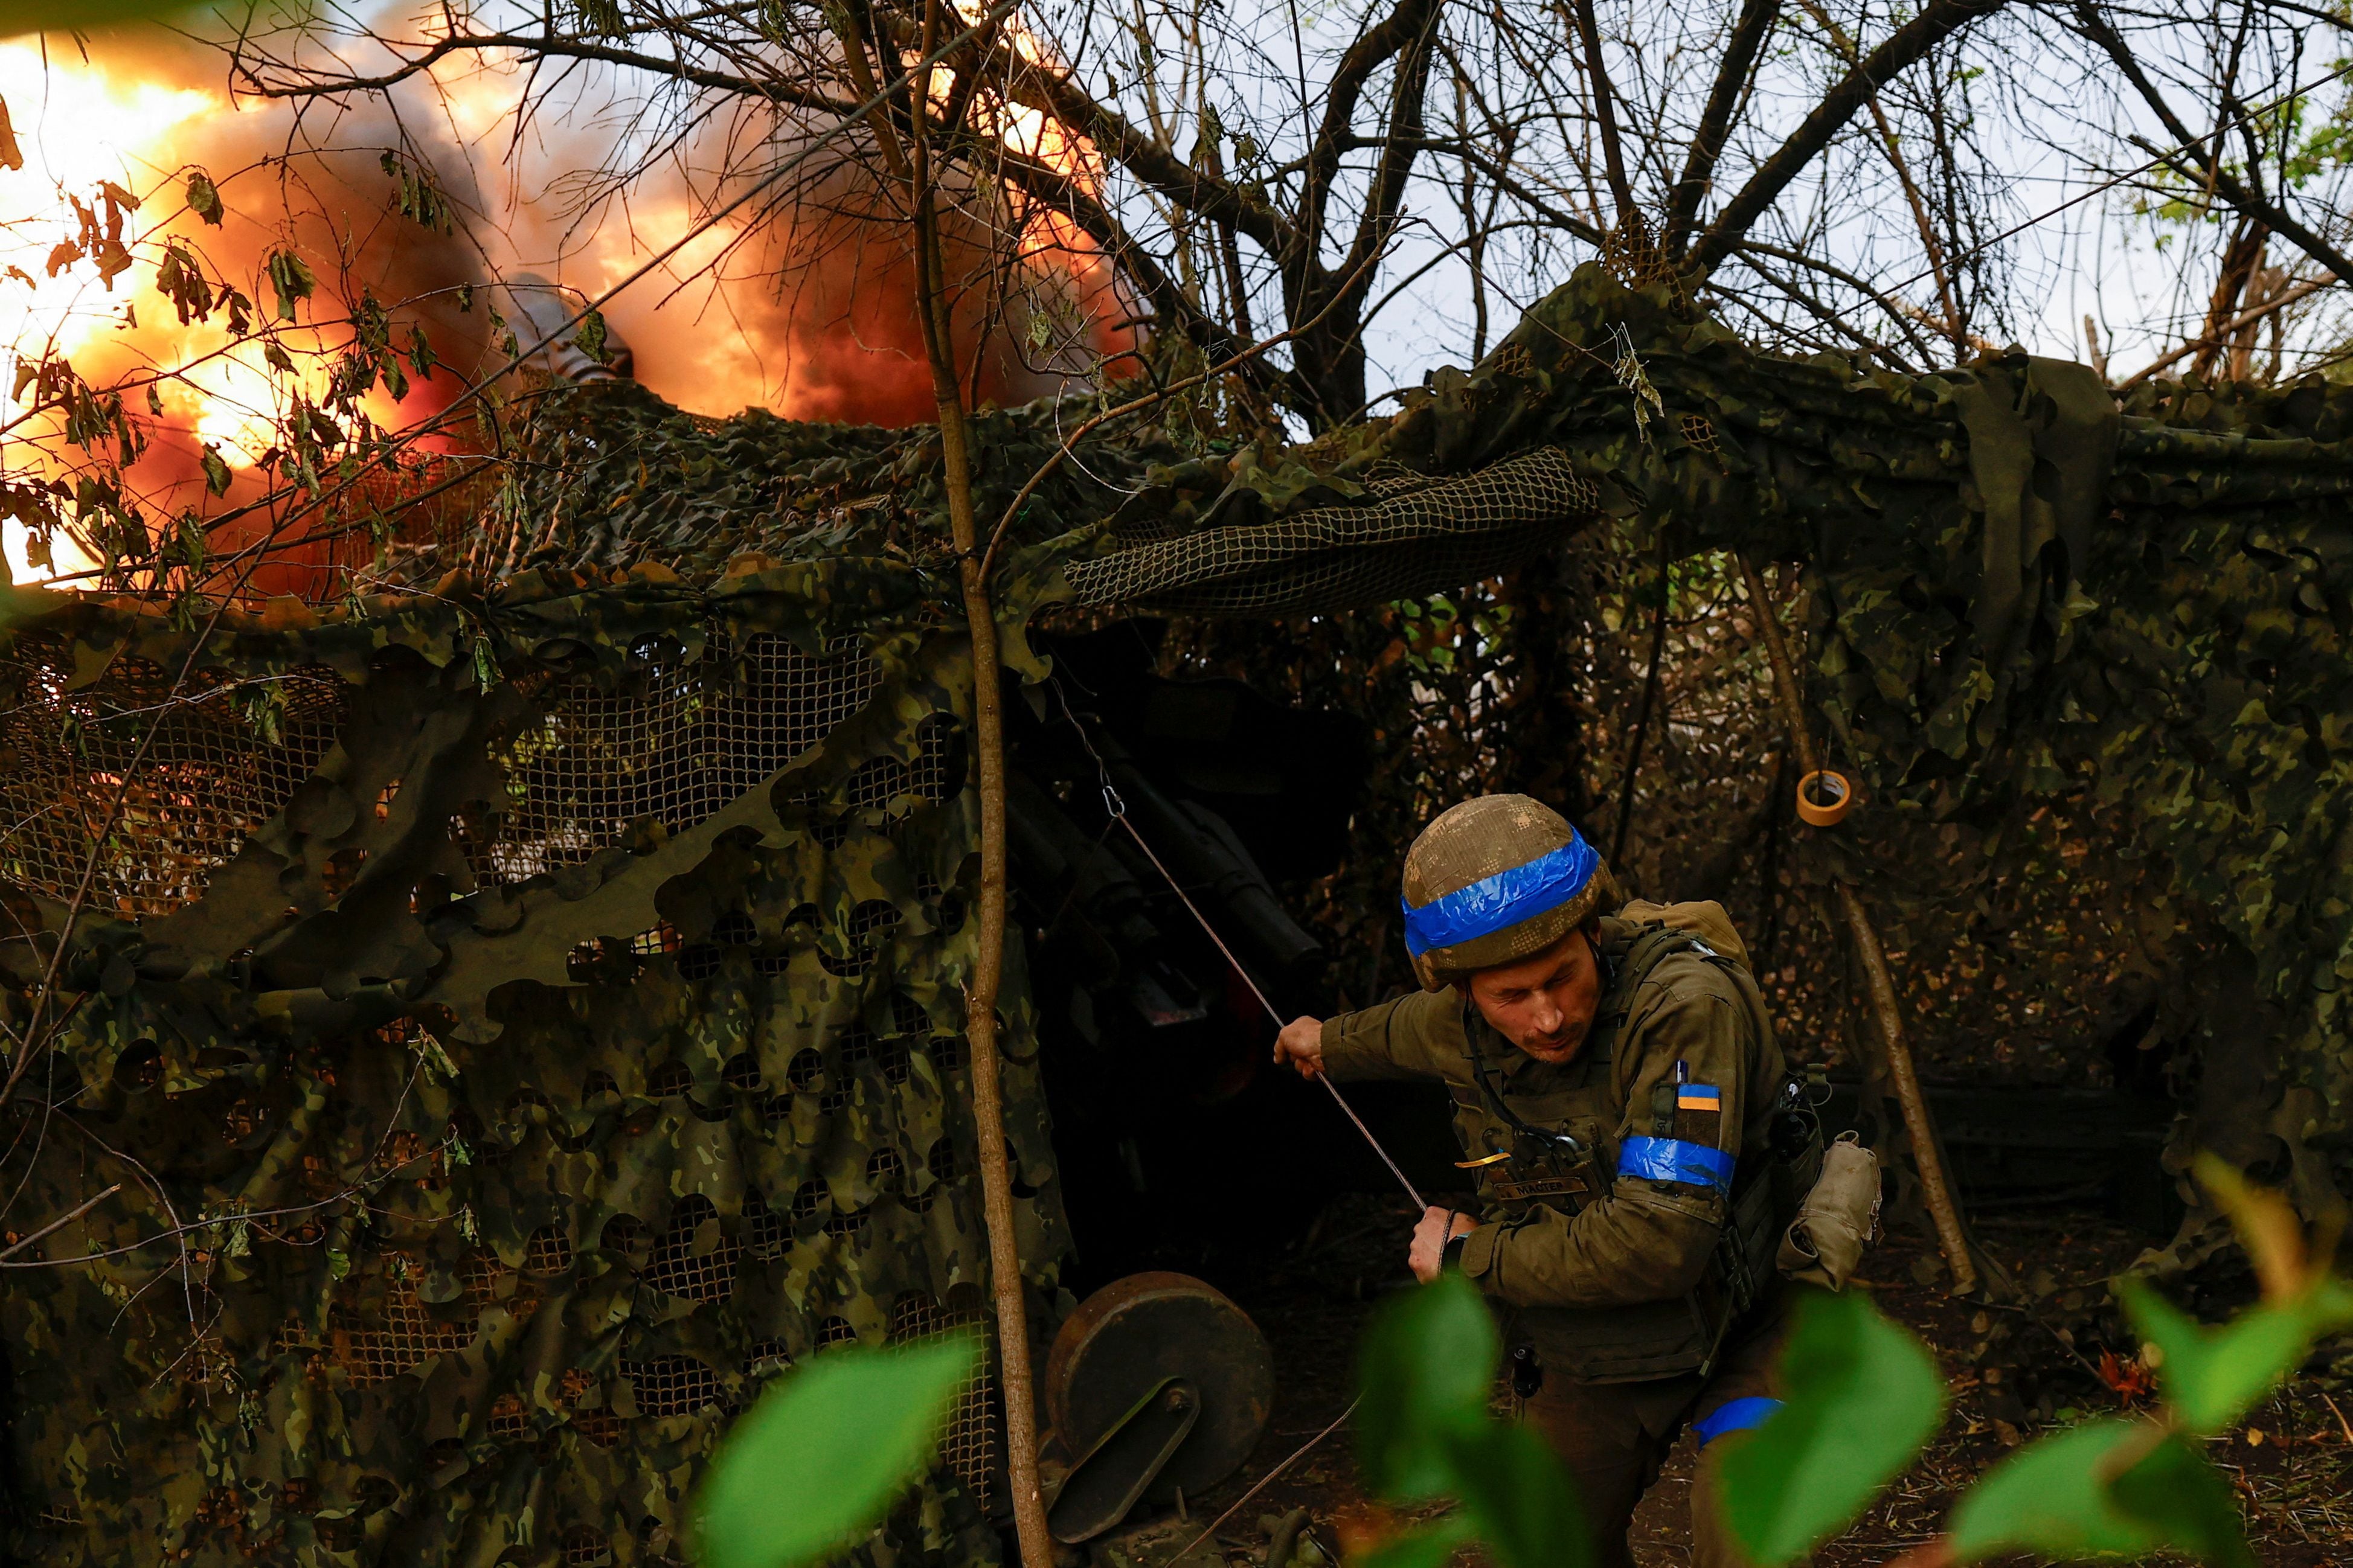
[0,560,1066,1566]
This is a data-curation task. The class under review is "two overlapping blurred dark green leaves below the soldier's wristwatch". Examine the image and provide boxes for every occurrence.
[1358,1272,1591,1568]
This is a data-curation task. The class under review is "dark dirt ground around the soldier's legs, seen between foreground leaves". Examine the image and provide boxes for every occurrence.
[1073,1197,2353,1568]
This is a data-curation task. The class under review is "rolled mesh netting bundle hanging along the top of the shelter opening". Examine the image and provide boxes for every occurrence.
[1066,447,1600,616]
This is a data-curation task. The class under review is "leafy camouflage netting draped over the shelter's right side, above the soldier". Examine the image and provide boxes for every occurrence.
[1071,268,2353,1241]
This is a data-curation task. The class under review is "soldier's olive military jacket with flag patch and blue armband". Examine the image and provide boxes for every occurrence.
[1323,905,1781,1382]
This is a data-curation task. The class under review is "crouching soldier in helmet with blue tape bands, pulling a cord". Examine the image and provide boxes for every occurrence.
[1276,795,1788,1568]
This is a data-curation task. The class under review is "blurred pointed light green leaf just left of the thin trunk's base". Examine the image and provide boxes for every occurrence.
[696,1337,981,1568]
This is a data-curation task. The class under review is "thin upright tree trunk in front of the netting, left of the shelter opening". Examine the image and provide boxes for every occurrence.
[911,0,1054,1568]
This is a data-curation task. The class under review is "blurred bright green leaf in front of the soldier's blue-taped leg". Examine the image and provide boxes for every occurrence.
[1718,1291,1944,1568]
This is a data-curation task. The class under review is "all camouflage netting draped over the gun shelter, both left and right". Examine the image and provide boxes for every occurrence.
[0,270,2353,1568]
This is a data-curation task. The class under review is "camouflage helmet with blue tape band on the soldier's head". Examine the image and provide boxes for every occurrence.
[1402,795,1619,992]
